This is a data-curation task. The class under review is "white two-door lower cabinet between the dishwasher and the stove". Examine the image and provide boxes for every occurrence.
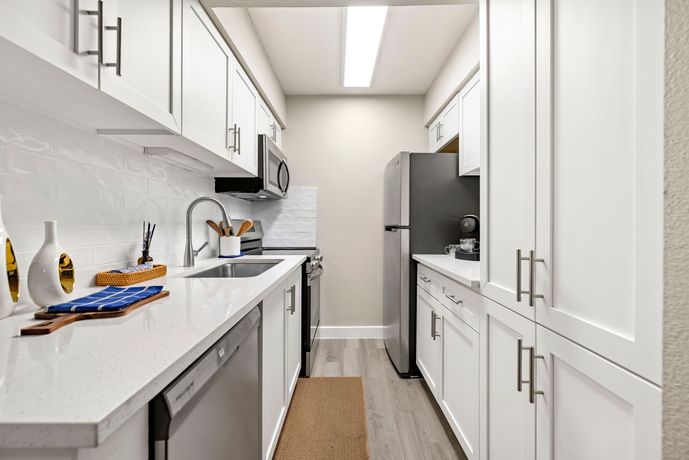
[261,268,301,460]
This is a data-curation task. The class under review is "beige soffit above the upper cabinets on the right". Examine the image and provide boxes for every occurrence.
[423,13,480,125]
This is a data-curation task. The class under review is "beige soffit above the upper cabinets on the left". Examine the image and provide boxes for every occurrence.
[211,8,287,128]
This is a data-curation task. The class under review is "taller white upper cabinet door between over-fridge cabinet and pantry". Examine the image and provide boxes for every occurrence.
[459,74,481,176]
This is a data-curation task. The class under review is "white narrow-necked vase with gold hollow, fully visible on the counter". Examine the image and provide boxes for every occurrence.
[29,220,75,307]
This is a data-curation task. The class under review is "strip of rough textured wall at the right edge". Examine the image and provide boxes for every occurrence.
[663,0,689,460]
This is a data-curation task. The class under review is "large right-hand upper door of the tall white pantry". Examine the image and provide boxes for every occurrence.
[532,0,664,384]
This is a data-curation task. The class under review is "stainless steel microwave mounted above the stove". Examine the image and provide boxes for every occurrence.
[215,134,289,201]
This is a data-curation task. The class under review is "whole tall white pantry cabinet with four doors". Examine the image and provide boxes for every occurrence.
[481,0,664,459]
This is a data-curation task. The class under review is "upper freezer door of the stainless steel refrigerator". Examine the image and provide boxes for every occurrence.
[383,153,409,226]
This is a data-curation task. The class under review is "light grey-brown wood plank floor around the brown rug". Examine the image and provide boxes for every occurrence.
[312,340,466,460]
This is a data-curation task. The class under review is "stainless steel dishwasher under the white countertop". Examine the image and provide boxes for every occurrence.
[149,307,261,460]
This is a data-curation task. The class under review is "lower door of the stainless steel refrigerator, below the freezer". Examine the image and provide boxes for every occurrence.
[383,228,410,374]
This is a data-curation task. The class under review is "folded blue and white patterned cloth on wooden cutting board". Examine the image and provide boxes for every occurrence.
[46,286,163,313]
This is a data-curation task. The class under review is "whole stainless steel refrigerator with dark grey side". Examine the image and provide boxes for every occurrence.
[383,152,479,377]
